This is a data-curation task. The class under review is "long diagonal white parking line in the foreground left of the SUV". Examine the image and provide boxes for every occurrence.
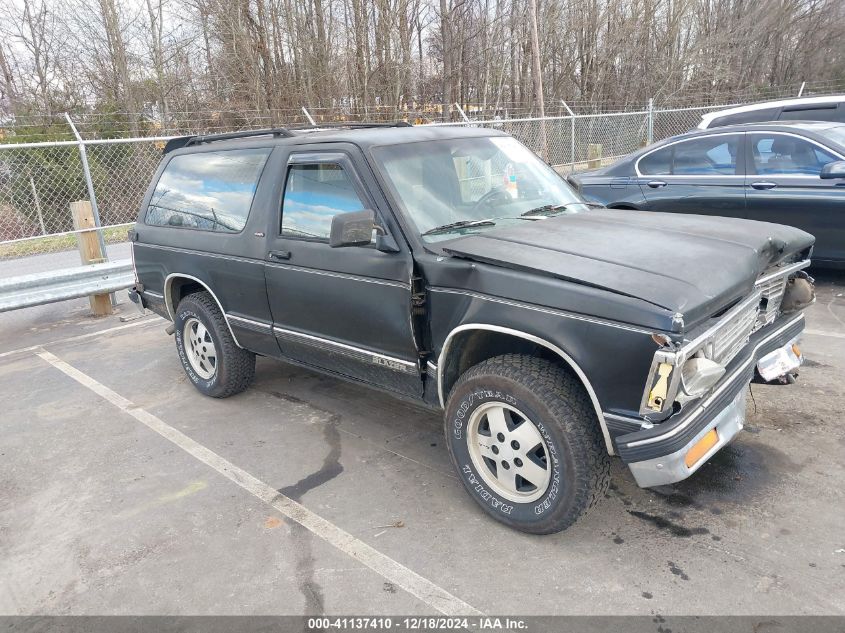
[36,349,483,616]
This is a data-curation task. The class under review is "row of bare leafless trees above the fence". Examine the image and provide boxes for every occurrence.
[0,0,845,132]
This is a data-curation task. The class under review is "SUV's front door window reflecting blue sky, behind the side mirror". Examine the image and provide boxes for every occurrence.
[282,163,367,240]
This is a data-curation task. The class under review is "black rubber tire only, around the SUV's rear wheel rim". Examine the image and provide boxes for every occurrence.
[174,292,255,398]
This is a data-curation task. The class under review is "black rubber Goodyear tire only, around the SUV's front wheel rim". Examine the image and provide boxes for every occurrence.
[445,354,610,534]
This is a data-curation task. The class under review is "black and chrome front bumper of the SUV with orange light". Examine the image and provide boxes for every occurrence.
[616,314,804,488]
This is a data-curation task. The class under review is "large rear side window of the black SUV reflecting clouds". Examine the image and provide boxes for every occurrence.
[144,148,271,233]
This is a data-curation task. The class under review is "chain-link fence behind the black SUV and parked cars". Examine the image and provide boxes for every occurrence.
[0,101,760,259]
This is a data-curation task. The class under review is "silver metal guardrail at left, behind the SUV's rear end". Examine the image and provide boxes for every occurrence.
[0,259,135,312]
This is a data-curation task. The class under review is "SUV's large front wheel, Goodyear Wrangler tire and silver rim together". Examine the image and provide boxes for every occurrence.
[445,354,610,534]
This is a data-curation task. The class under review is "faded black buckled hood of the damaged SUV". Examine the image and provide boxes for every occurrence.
[443,209,815,326]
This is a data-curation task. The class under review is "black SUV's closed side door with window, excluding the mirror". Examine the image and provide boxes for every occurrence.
[265,144,422,397]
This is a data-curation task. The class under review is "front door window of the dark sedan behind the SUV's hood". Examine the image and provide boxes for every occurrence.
[751,134,839,176]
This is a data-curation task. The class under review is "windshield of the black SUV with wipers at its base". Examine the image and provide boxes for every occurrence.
[374,136,588,242]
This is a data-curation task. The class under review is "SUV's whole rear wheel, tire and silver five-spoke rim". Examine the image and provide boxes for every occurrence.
[174,292,255,398]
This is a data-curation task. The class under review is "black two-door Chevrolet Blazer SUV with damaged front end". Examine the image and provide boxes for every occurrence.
[130,124,814,534]
